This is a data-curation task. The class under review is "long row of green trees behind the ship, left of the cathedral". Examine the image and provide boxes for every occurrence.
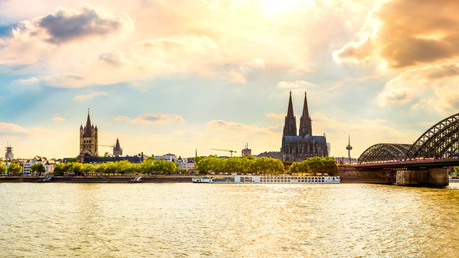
[195,155,285,174]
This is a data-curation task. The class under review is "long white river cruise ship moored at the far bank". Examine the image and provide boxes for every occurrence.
[192,175,340,184]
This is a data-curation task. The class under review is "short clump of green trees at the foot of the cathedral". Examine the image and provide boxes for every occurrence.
[290,157,338,175]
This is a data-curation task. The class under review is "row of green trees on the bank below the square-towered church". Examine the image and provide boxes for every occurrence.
[54,157,177,175]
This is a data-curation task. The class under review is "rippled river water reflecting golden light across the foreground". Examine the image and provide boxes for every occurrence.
[0,183,459,257]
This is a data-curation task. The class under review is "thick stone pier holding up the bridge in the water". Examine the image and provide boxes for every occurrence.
[396,168,449,187]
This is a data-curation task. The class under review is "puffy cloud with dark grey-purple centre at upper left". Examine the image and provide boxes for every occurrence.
[0,4,134,65]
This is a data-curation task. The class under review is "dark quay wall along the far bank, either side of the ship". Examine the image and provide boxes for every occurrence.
[0,176,392,184]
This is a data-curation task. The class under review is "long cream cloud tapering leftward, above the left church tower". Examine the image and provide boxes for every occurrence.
[37,36,219,88]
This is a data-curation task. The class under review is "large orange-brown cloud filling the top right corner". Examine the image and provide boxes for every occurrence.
[334,0,459,69]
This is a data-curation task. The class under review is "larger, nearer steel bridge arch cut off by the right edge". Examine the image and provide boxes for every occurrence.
[408,113,459,158]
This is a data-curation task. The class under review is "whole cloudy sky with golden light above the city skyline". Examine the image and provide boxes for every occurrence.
[0,0,459,158]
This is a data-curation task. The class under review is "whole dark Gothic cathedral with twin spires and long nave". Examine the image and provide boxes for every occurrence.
[280,92,328,160]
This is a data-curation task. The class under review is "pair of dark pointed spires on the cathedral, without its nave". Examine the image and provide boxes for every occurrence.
[284,92,312,137]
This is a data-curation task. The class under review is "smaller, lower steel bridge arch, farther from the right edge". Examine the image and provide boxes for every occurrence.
[358,143,411,163]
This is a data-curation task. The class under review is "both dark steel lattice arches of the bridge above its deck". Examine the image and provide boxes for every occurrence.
[358,113,459,163]
